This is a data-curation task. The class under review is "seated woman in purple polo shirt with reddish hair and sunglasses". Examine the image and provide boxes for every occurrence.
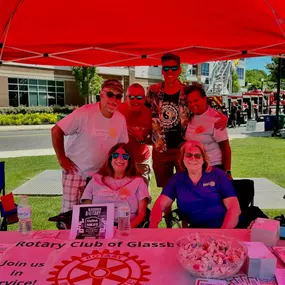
[150,140,241,229]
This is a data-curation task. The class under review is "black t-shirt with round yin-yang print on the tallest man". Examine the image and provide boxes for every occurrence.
[162,91,183,148]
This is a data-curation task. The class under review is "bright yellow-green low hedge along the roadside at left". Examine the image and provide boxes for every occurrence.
[0,113,57,126]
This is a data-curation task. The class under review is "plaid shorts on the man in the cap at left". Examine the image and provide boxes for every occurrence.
[61,170,86,213]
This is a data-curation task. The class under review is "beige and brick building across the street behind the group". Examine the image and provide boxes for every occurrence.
[0,60,245,107]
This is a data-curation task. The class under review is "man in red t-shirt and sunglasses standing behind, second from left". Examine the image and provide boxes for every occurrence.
[118,83,152,185]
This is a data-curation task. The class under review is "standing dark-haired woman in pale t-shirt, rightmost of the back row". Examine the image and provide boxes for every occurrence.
[185,85,231,178]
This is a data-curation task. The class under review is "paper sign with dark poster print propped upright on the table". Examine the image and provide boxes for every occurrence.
[69,203,114,239]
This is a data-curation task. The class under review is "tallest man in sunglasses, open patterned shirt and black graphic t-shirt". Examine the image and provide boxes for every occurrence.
[147,53,189,187]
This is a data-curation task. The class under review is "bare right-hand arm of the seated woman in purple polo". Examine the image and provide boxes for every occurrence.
[221,197,241,229]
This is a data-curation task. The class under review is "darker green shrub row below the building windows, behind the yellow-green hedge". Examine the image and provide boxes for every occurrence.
[0,105,76,115]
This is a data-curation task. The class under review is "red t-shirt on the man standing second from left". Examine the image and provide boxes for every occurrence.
[119,102,151,163]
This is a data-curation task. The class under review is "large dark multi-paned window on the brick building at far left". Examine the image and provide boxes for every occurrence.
[8,78,64,107]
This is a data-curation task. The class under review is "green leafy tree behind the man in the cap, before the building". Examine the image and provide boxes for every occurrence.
[72,66,103,103]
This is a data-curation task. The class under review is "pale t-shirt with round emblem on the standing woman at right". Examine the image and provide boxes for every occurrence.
[185,107,229,165]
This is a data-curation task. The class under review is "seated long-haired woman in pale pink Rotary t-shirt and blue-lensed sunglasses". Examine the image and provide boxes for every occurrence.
[81,143,151,228]
